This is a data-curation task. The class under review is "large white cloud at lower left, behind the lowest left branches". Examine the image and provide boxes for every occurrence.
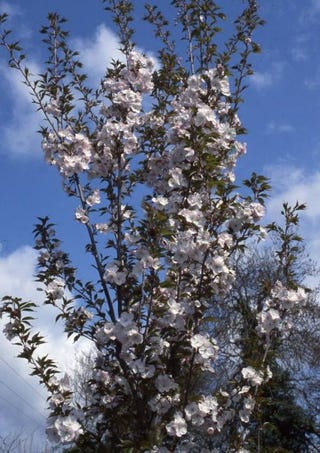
[0,246,89,439]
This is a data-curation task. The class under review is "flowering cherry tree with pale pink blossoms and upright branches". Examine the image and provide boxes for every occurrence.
[1,0,306,453]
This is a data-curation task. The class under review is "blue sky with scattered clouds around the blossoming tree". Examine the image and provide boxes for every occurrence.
[0,0,320,444]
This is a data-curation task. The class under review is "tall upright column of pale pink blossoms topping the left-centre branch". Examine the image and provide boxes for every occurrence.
[89,51,154,177]
